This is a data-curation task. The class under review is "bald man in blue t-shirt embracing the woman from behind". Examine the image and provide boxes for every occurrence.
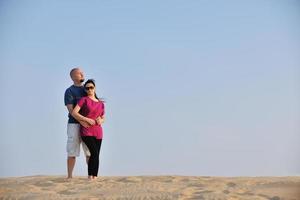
[64,68,101,179]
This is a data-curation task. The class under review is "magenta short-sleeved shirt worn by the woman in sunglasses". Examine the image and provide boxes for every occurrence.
[77,97,104,139]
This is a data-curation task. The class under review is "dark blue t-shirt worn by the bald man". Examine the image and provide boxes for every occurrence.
[65,85,85,124]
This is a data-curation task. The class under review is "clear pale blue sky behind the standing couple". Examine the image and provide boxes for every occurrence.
[0,0,300,177]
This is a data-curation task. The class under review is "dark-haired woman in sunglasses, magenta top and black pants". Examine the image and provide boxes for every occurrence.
[72,79,104,179]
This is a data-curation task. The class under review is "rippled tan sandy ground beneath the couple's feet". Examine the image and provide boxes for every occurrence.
[0,176,300,200]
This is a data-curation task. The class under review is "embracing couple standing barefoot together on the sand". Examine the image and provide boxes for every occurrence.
[64,68,104,179]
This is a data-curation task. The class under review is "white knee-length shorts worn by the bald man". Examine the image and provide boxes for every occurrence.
[67,123,91,157]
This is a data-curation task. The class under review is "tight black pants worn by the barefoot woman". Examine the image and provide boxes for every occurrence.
[81,136,102,176]
